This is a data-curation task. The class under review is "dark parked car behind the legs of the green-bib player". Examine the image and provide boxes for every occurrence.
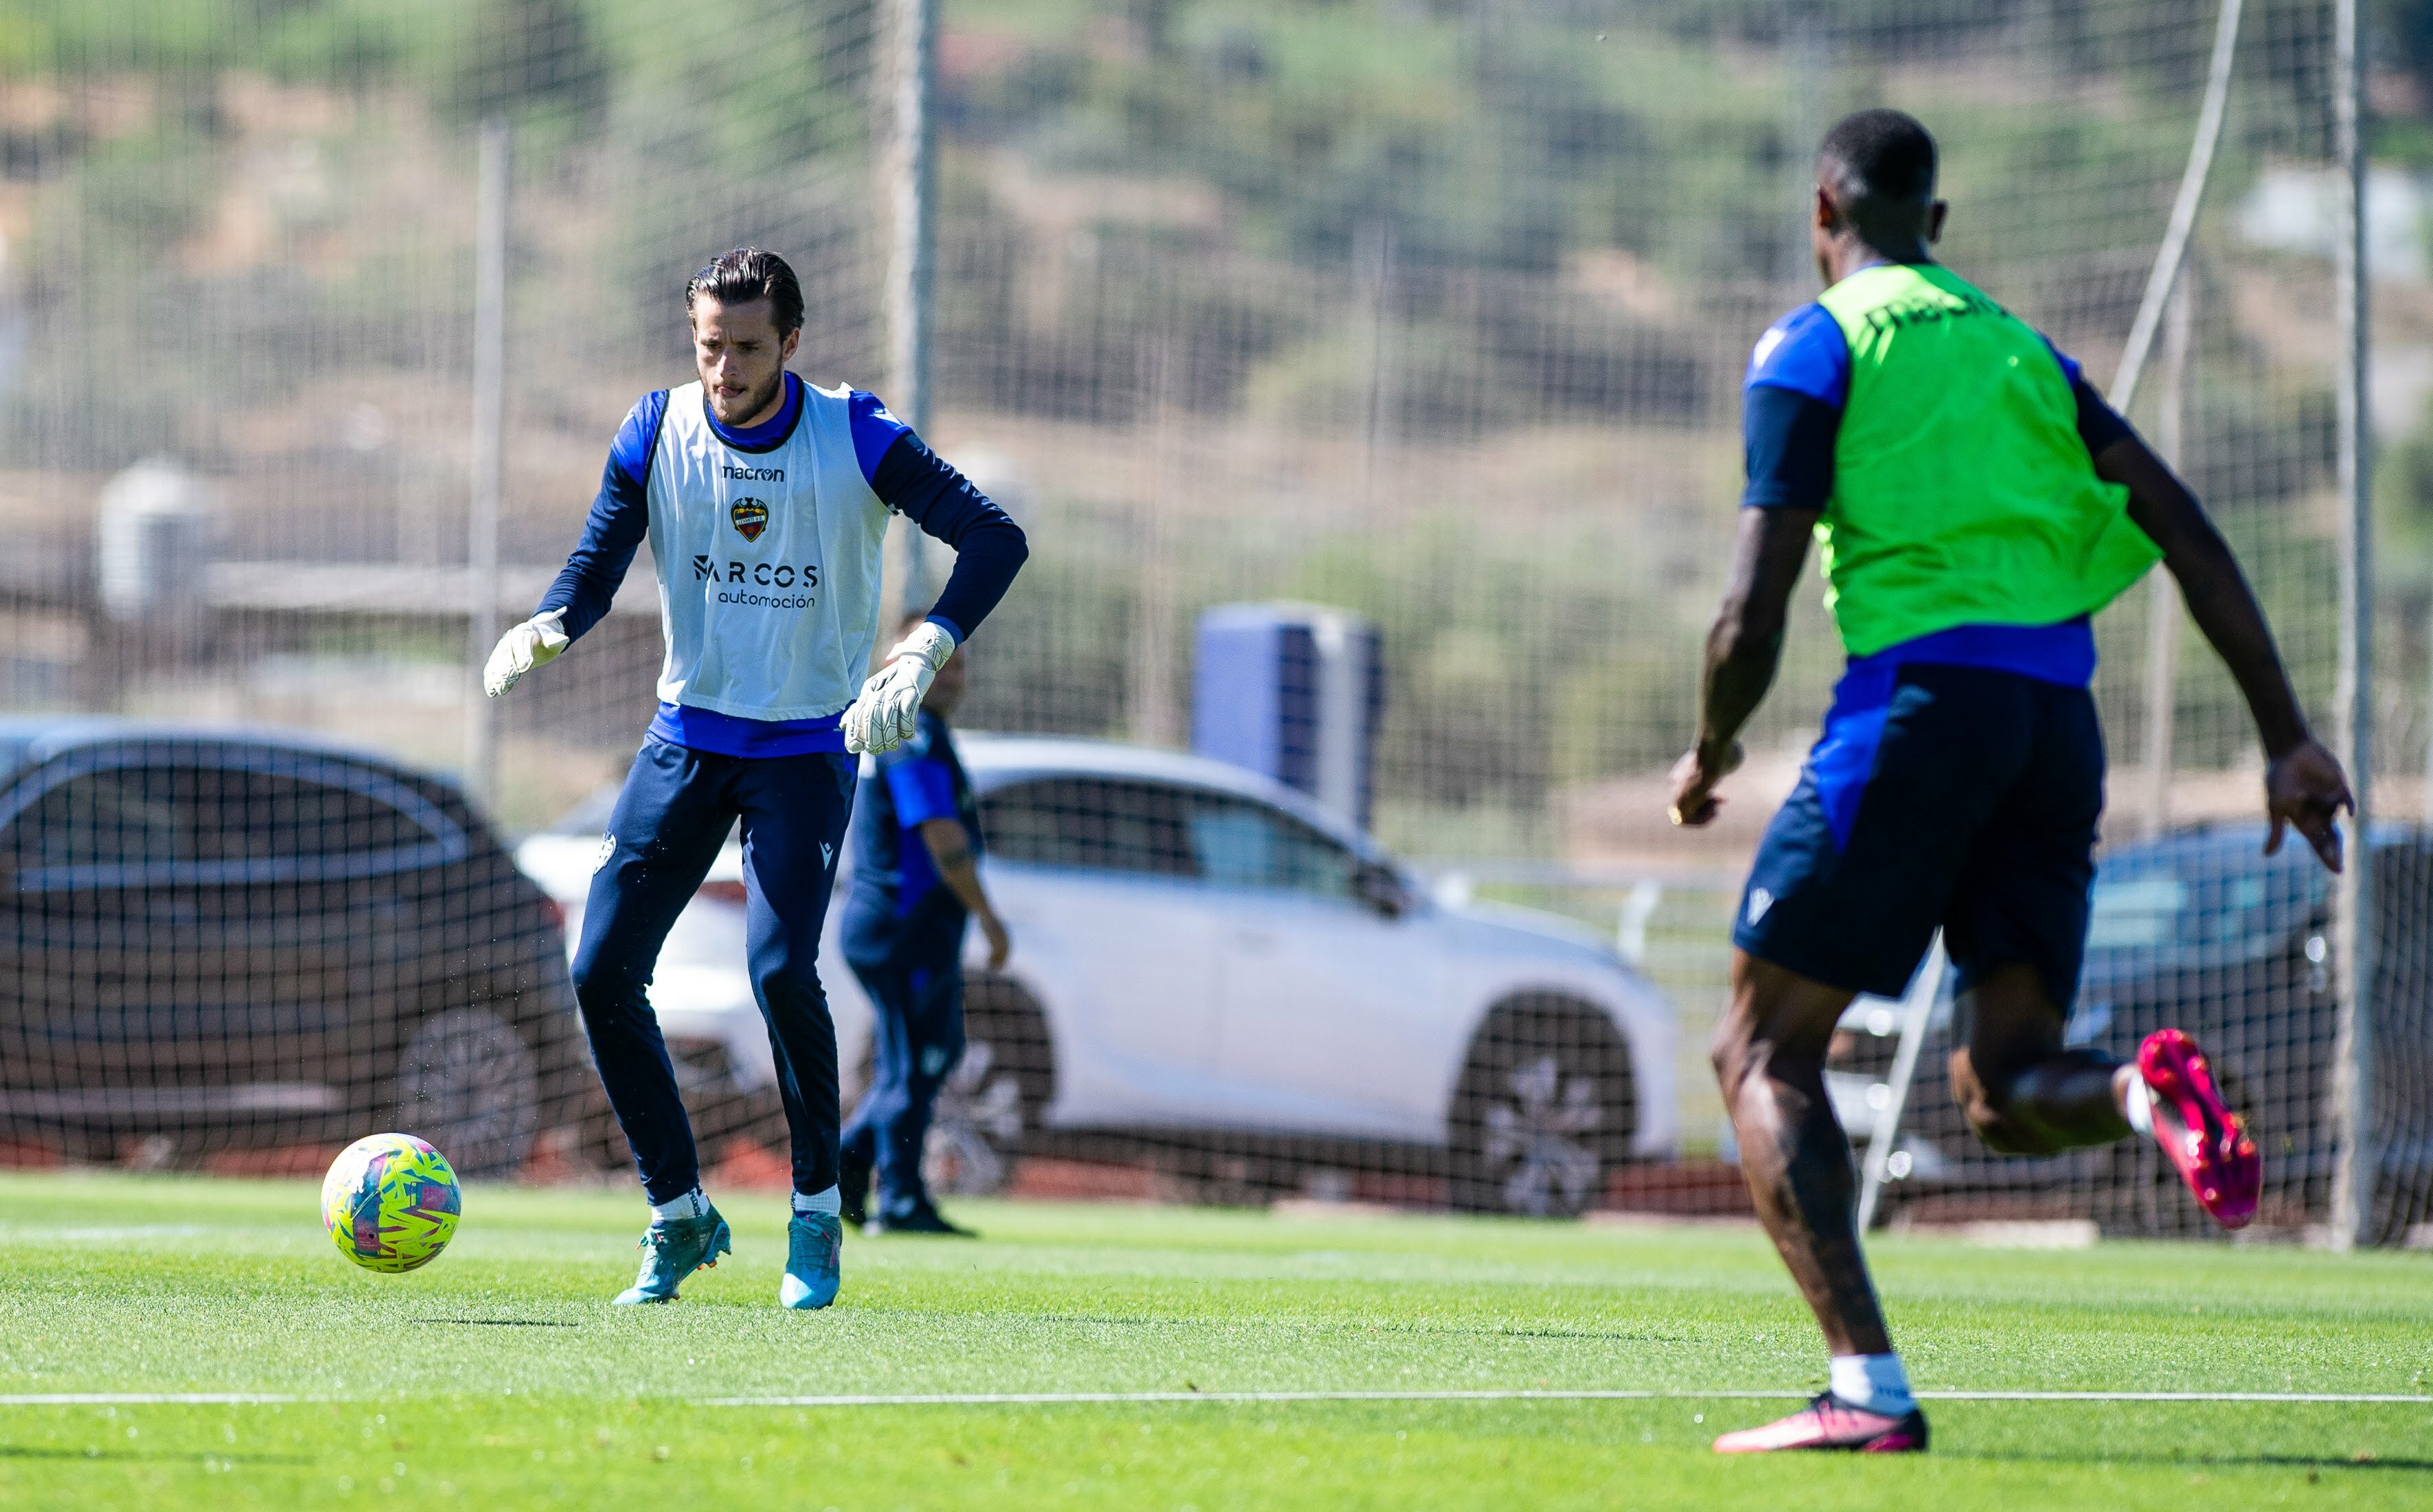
[1834,824,2433,1239]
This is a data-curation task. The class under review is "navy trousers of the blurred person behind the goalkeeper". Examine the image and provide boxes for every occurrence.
[842,957,963,1218]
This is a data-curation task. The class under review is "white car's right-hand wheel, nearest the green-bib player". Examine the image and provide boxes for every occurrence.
[1448,994,1637,1218]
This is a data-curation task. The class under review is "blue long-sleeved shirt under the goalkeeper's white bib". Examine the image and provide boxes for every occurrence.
[535,372,1029,756]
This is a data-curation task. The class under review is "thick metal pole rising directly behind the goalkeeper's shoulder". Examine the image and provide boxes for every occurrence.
[881,0,937,632]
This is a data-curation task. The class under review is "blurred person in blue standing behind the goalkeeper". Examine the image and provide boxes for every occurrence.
[839,615,1014,1237]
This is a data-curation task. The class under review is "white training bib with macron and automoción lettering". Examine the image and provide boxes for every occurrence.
[650,382,888,720]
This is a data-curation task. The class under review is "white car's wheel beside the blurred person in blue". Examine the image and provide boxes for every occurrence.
[922,972,1056,1196]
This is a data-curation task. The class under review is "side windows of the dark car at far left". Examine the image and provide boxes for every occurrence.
[5,764,443,873]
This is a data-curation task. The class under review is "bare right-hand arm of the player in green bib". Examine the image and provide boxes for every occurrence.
[2095,435,2357,870]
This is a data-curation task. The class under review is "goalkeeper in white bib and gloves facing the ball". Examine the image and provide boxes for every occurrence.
[484,248,1029,1308]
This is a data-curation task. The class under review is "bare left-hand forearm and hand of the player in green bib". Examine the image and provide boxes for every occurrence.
[1671,508,1820,824]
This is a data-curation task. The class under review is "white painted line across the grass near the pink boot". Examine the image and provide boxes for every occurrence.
[0,1390,2433,1408]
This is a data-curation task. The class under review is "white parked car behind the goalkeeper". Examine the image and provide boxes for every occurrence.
[518,734,1676,1213]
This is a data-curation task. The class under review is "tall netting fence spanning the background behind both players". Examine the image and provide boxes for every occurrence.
[0,0,2433,1239]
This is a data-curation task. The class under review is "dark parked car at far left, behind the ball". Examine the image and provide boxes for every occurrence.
[0,717,589,1174]
